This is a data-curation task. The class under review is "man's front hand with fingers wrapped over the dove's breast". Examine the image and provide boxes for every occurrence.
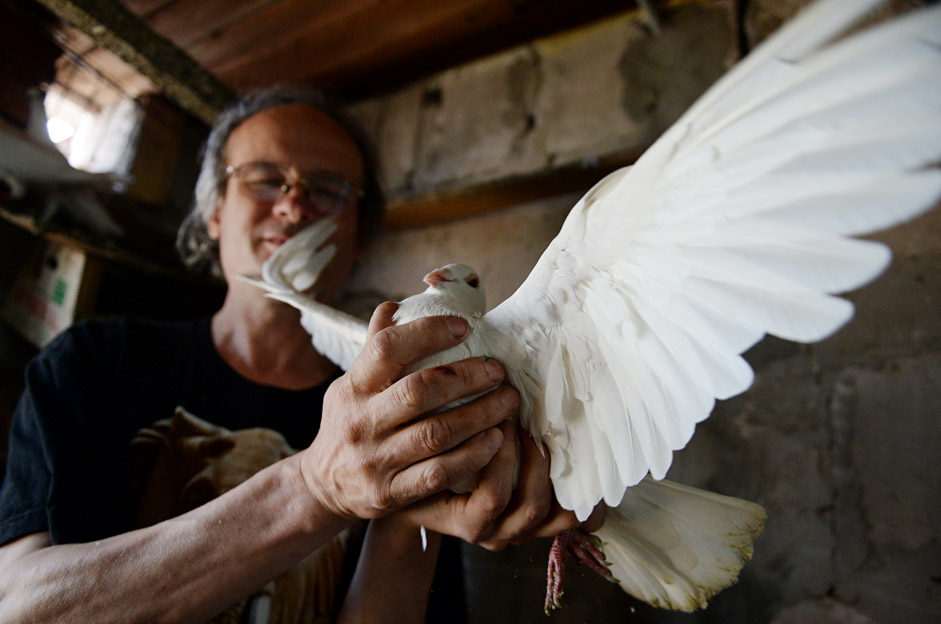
[301,303,519,518]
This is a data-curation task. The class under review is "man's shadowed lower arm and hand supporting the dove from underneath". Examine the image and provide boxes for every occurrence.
[338,422,605,624]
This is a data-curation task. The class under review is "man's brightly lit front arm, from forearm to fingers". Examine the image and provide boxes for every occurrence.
[0,306,518,623]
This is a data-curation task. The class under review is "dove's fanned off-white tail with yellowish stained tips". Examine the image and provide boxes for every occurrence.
[596,477,766,611]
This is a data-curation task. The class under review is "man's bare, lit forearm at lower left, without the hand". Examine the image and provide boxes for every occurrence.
[0,456,348,623]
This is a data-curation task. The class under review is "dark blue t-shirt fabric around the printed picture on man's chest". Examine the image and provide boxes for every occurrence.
[0,318,328,544]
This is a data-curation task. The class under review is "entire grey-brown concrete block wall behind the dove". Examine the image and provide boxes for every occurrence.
[348,0,941,624]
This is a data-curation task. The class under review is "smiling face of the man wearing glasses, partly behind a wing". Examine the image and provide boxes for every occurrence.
[209,104,364,302]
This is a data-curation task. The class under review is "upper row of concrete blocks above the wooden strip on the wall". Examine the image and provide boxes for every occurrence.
[351,0,738,197]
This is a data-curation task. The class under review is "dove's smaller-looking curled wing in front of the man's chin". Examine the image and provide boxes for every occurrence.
[239,217,368,370]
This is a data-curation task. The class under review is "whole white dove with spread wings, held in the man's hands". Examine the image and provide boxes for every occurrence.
[246,0,941,610]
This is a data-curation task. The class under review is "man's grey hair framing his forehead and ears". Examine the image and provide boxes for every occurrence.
[176,85,385,275]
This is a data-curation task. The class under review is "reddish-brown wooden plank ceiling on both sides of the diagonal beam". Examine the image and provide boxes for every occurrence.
[53,0,636,107]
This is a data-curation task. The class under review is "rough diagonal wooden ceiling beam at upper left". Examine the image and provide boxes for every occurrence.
[36,0,234,124]
